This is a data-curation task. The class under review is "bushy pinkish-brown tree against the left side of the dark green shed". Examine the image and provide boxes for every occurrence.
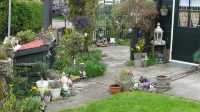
[113,0,157,32]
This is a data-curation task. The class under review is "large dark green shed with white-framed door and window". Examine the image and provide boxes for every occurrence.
[157,0,200,65]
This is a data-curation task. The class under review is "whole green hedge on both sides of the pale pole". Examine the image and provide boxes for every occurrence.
[0,0,43,39]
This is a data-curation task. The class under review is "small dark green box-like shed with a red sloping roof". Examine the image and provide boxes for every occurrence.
[14,39,56,67]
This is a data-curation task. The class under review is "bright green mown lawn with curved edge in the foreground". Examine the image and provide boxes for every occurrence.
[60,91,200,112]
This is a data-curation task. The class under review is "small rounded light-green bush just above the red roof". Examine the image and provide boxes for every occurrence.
[16,30,36,44]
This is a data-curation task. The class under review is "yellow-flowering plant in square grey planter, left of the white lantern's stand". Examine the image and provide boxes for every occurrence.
[132,38,147,67]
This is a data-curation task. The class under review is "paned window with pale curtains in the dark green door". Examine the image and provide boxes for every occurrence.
[179,0,200,28]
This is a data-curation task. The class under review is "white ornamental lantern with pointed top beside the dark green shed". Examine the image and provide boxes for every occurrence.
[152,23,166,45]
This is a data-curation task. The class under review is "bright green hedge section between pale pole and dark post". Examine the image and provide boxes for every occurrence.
[11,0,43,34]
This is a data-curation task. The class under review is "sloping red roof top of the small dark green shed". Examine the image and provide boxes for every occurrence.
[18,39,45,51]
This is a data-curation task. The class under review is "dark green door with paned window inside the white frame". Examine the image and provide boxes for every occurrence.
[172,0,200,63]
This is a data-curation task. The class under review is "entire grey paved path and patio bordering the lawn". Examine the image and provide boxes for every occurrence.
[48,46,200,112]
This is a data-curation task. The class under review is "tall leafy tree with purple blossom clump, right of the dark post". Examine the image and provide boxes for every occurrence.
[68,0,98,52]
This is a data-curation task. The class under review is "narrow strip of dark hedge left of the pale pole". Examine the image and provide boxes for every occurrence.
[0,0,8,40]
